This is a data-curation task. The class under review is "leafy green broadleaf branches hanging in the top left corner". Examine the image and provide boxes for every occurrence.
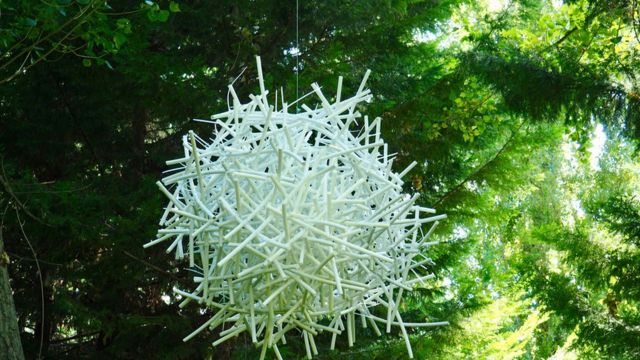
[0,0,175,83]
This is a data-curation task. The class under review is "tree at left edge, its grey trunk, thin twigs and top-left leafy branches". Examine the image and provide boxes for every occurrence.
[0,1,179,358]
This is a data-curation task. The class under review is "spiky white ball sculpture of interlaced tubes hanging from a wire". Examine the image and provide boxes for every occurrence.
[145,58,446,358]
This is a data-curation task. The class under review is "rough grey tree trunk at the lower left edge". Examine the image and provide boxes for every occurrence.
[0,229,24,360]
